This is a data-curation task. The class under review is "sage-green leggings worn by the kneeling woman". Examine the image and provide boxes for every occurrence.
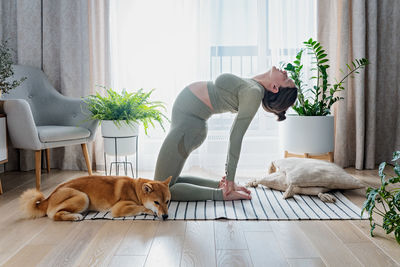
[154,87,223,201]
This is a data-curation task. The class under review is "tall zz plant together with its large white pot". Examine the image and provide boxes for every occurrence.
[280,38,368,161]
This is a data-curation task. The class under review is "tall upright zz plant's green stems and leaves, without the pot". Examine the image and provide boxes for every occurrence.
[284,38,368,116]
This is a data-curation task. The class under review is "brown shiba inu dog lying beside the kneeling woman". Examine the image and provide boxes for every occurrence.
[20,176,172,221]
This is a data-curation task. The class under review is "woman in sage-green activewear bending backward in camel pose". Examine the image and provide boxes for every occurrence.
[154,67,297,201]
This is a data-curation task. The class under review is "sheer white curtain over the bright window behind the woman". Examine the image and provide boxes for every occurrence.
[110,0,316,175]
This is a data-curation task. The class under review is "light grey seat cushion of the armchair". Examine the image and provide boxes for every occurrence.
[37,125,90,143]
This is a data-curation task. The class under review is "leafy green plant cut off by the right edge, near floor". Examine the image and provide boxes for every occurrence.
[361,151,400,244]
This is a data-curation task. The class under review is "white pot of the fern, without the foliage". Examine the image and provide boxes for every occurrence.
[101,121,139,156]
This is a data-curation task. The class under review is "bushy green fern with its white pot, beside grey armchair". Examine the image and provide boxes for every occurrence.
[85,87,168,156]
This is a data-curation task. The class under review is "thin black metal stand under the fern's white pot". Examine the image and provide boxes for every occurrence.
[103,135,139,178]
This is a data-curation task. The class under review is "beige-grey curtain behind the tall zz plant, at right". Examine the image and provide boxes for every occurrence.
[317,0,400,169]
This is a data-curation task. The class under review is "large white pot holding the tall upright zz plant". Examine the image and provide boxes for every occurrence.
[279,114,334,155]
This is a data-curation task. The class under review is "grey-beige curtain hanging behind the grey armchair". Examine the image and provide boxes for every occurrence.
[0,0,110,170]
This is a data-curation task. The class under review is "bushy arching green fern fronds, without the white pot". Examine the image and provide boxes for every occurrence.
[84,87,168,134]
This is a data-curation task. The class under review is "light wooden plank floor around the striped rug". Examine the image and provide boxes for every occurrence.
[0,169,400,267]
